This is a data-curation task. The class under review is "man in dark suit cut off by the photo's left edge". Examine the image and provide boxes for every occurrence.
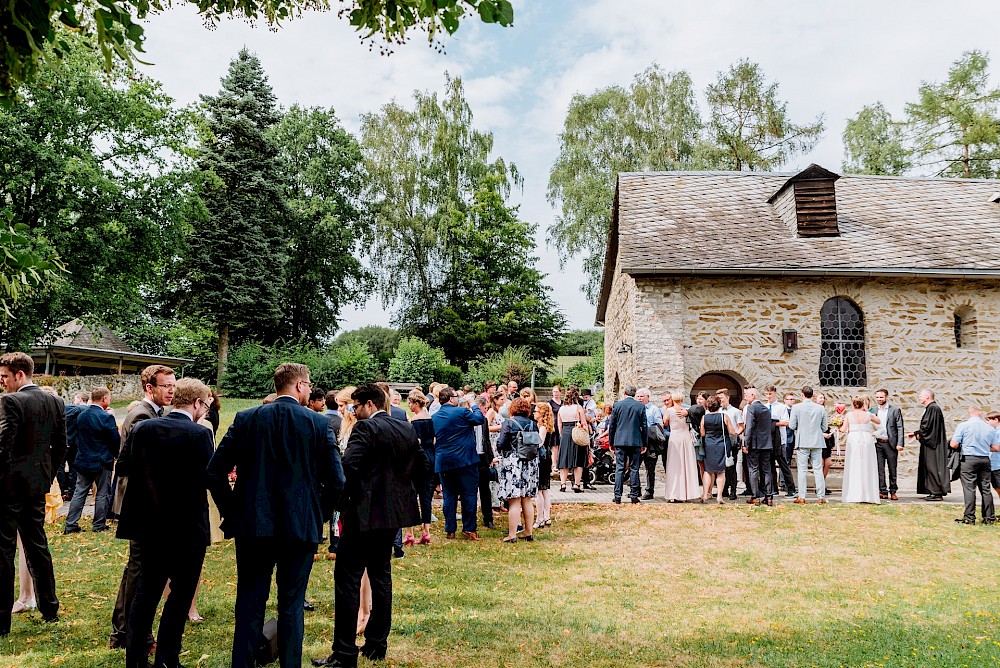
[0,353,66,637]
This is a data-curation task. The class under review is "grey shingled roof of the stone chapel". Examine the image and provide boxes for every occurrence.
[597,166,1000,323]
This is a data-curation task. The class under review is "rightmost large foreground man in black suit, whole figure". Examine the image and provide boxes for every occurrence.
[313,384,430,668]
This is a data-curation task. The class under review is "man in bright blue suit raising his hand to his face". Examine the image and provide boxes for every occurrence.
[431,387,486,540]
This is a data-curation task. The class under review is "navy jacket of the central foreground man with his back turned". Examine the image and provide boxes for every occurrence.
[208,396,344,543]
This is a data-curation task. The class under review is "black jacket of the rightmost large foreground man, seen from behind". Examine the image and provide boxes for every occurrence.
[340,411,430,531]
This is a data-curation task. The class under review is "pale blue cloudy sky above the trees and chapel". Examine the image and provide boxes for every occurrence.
[142,0,1000,331]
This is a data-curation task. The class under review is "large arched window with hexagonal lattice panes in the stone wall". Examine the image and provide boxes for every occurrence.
[819,297,868,387]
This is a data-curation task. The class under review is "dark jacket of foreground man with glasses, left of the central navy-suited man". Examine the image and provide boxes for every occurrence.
[116,411,215,546]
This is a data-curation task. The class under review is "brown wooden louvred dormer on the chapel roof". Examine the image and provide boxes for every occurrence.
[767,165,840,237]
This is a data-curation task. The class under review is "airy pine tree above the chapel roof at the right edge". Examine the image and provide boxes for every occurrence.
[906,51,1000,178]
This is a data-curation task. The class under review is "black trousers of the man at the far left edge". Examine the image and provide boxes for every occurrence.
[0,494,59,636]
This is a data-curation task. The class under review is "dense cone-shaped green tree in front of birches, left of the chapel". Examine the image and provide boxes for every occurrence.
[397,176,566,365]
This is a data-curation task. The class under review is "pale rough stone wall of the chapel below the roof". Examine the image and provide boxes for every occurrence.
[605,274,1000,431]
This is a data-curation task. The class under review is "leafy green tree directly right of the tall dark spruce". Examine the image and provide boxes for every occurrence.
[270,105,366,343]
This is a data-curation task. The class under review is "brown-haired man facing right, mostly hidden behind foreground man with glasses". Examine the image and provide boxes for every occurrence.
[109,364,177,649]
